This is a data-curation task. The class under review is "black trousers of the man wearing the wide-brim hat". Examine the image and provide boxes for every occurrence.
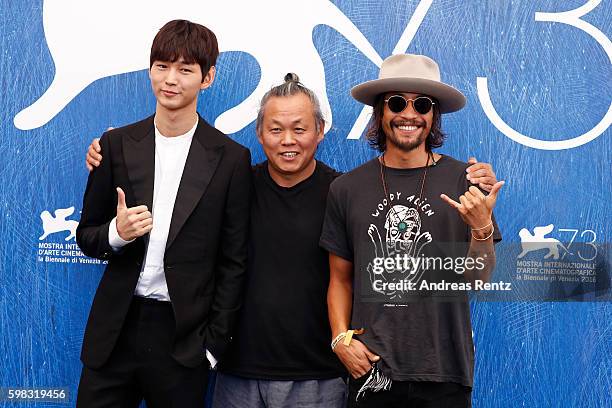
[348,374,472,408]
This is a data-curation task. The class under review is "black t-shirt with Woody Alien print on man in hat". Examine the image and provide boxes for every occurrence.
[320,156,501,386]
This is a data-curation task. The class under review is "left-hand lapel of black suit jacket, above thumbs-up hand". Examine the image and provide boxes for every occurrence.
[121,116,155,211]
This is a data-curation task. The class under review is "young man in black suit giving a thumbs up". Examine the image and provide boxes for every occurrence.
[77,20,251,407]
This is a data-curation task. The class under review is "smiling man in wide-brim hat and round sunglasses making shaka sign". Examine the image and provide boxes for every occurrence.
[320,54,503,407]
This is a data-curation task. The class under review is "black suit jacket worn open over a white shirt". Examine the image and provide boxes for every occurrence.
[77,117,251,368]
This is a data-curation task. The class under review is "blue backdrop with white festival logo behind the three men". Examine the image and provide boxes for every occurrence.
[0,0,612,407]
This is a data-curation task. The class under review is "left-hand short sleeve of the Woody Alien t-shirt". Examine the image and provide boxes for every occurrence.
[319,181,353,262]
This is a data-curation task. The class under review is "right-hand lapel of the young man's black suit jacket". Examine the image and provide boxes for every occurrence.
[166,118,223,249]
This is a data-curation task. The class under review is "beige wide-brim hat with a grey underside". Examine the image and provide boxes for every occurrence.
[351,54,466,113]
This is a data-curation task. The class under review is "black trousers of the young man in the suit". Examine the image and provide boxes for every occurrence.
[77,297,208,408]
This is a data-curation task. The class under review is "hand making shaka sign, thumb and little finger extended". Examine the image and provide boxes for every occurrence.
[440,181,504,236]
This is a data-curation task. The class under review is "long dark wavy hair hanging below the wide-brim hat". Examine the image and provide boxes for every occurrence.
[366,94,446,153]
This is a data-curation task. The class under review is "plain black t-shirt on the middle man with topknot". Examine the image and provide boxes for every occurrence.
[220,162,346,380]
